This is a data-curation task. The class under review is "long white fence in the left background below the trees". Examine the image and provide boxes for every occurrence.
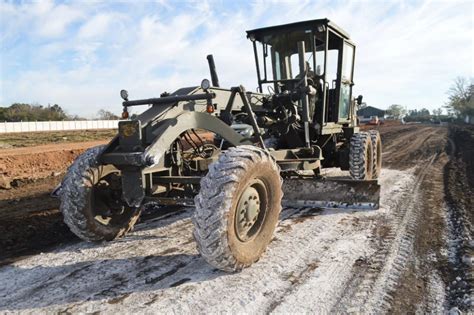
[0,120,119,133]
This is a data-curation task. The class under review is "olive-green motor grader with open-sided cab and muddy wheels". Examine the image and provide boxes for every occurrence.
[59,19,382,271]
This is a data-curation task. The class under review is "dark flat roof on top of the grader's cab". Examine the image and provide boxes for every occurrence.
[247,19,350,41]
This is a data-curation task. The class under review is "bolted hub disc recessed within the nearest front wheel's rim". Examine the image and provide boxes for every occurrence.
[236,186,260,241]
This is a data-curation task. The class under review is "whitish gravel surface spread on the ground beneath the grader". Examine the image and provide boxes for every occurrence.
[0,170,443,314]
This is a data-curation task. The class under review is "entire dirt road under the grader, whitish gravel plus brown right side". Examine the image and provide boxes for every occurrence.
[0,125,474,313]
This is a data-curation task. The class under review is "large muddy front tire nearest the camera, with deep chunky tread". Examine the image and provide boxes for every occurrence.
[193,146,283,272]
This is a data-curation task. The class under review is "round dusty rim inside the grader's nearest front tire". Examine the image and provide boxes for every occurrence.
[235,179,268,242]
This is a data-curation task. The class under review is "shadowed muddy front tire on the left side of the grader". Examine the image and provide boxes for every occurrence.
[60,146,140,241]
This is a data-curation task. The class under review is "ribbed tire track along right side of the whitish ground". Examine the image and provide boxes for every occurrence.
[334,154,437,314]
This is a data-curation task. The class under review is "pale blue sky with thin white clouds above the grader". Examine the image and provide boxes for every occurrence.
[0,0,474,117]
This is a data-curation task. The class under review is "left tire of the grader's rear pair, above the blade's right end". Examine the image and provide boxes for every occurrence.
[349,132,374,180]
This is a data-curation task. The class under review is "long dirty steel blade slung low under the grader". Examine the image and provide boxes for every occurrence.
[283,178,380,209]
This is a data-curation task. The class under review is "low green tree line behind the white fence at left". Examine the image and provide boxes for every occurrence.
[0,103,120,122]
